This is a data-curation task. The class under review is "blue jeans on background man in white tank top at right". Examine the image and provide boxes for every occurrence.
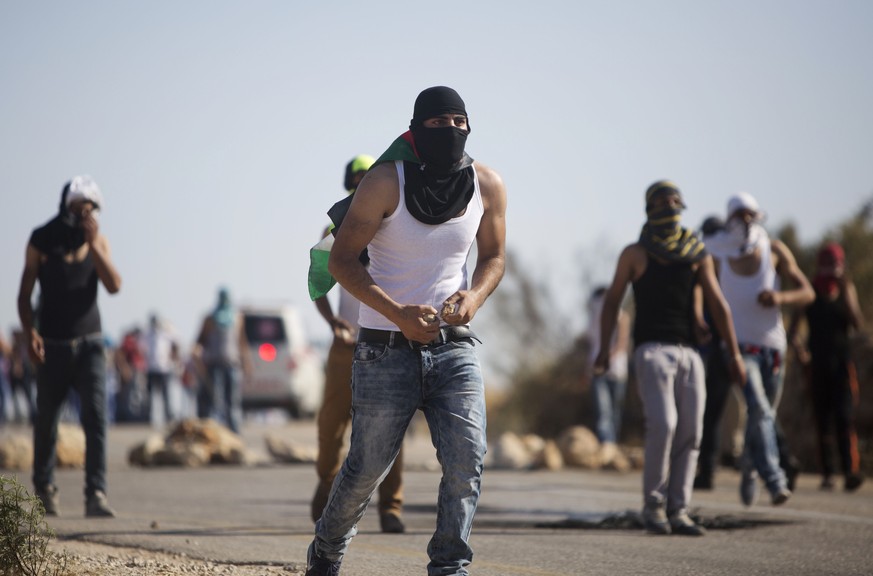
[741,346,787,493]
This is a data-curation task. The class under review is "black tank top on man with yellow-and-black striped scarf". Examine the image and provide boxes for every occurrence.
[633,255,696,346]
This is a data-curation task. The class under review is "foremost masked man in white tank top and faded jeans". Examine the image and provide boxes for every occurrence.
[306,86,506,576]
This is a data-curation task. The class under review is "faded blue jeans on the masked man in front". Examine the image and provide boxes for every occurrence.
[315,340,486,576]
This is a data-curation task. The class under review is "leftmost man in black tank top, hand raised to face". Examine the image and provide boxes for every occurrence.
[18,176,121,517]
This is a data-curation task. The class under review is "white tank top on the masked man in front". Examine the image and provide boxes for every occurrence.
[359,160,485,330]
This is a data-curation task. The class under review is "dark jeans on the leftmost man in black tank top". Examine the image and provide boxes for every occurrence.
[33,335,106,496]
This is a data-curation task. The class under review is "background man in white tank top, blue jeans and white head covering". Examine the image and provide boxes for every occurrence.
[707,192,815,506]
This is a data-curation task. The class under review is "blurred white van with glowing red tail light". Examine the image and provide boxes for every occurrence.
[240,305,324,418]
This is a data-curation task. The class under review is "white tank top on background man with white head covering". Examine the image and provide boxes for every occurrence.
[719,238,786,350]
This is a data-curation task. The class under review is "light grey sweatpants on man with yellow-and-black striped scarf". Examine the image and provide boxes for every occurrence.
[634,342,706,514]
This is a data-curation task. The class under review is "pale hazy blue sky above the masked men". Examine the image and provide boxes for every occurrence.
[0,0,873,356]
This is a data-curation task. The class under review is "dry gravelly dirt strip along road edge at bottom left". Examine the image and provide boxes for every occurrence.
[50,540,303,576]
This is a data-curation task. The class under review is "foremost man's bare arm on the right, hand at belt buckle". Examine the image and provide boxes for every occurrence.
[442,163,506,325]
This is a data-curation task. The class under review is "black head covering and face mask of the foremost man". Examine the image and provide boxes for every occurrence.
[404,86,475,224]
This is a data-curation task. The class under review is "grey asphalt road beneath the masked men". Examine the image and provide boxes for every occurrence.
[3,421,873,576]
